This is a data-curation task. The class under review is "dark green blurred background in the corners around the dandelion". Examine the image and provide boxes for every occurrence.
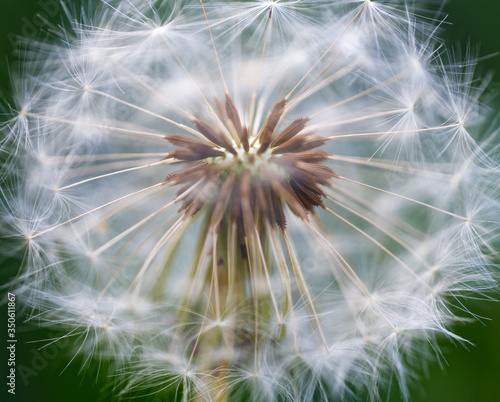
[0,0,500,402]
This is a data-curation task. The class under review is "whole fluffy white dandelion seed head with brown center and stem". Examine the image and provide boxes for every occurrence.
[2,0,500,401]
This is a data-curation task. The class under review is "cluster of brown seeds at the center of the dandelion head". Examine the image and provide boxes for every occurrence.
[165,95,337,231]
